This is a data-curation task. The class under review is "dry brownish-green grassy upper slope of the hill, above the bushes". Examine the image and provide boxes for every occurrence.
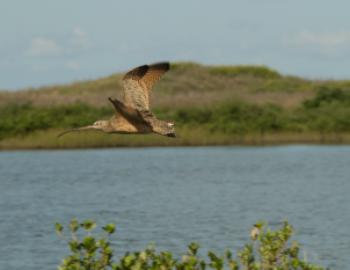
[0,63,314,107]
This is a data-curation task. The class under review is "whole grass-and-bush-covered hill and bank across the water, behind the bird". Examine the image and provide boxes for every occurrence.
[0,63,350,149]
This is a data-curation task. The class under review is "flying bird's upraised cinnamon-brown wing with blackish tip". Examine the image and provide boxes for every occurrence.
[123,62,170,111]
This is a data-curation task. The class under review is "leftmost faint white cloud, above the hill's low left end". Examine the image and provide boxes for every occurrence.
[28,37,63,56]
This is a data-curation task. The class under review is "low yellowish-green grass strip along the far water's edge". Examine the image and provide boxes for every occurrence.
[0,128,350,151]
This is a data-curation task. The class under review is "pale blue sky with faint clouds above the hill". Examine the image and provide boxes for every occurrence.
[0,0,350,90]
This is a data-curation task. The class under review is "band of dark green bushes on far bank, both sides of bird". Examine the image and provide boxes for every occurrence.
[0,92,350,140]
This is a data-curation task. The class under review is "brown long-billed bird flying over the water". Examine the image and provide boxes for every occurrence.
[58,62,176,137]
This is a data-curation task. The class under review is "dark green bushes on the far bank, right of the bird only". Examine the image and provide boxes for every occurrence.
[169,85,350,135]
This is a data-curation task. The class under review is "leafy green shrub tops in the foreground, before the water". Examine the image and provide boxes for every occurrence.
[56,219,323,270]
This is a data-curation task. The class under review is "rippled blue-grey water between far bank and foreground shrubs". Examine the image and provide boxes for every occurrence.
[0,146,350,270]
